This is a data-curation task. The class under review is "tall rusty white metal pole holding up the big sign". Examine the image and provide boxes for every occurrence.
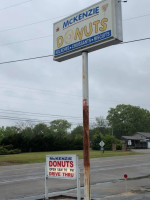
[82,52,90,200]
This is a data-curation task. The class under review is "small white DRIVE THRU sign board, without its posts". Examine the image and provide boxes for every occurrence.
[46,155,78,180]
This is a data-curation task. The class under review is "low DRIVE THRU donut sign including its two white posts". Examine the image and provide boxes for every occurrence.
[45,155,80,200]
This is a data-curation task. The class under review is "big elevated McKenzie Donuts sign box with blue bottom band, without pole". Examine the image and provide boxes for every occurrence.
[53,0,122,61]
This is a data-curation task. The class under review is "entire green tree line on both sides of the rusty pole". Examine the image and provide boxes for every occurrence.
[0,104,150,154]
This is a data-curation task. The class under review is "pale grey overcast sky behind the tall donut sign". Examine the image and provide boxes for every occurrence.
[0,0,150,126]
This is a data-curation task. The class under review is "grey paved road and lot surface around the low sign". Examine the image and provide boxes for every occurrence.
[0,154,150,200]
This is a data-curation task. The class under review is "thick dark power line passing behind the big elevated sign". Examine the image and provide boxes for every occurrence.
[0,37,150,65]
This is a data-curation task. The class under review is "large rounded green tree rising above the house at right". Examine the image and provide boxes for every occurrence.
[107,104,150,138]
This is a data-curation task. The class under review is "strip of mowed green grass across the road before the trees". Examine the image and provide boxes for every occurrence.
[0,150,137,166]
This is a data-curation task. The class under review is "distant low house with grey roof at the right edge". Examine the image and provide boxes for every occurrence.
[122,132,150,149]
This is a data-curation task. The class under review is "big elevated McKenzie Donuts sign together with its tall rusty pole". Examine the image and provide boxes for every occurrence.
[53,0,123,200]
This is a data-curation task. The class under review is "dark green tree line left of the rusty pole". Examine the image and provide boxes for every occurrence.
[0,119,82,152]
